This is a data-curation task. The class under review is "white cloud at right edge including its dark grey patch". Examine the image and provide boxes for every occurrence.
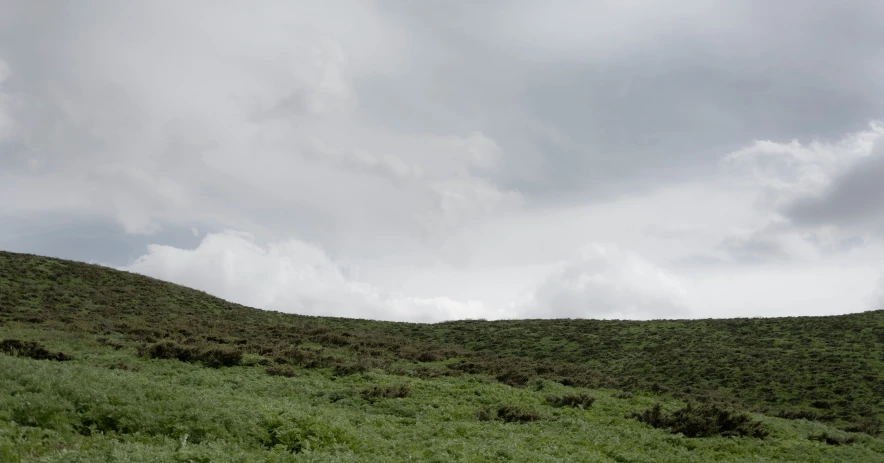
[716,121,884,264]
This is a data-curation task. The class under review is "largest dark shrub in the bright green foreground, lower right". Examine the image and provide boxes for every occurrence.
[628,402,768,438]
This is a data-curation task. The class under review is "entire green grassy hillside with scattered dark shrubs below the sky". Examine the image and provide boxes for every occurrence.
[0,252,884,463]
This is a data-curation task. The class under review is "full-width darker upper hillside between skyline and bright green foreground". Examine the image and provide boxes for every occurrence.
[0,251,884,462]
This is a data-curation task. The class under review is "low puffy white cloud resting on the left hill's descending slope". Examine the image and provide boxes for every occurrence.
[121,231,499,322]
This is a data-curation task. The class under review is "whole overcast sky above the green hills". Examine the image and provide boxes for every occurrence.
[0,0,884,322]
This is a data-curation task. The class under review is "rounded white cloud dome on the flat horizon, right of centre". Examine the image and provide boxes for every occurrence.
[519,243,690,319]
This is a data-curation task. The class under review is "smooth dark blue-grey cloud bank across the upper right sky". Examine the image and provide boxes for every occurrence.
[364,1,884,201]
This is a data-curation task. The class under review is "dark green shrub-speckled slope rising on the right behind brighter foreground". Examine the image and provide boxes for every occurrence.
[424,311,884,434]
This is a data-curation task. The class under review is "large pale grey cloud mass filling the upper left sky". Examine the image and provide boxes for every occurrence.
[0,1,523,260]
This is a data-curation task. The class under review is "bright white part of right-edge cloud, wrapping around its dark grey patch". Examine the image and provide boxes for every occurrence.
[686,122,884,265]
